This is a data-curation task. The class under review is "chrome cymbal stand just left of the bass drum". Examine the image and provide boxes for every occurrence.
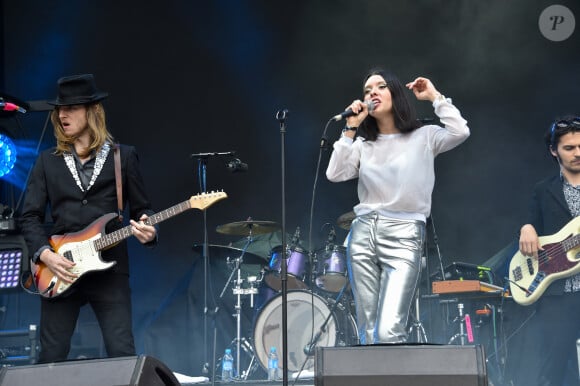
[220,232,258,379]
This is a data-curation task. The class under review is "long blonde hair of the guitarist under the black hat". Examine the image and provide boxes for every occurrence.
[50,102,114,157]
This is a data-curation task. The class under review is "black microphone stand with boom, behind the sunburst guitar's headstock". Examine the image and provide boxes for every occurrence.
[190,151,236,375]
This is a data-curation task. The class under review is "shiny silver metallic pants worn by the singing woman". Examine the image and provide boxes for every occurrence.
[347,213,425,344]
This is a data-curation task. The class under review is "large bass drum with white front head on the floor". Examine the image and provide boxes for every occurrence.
[254,291,358,372]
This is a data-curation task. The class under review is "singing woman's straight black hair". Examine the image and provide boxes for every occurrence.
[360,67,421,141]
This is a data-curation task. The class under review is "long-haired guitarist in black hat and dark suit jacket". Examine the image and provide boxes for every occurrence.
[21,74,157,363]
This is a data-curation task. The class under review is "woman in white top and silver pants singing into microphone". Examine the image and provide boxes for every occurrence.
[326,69,469,344]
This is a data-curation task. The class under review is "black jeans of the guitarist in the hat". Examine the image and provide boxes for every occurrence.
[39,271,135,363]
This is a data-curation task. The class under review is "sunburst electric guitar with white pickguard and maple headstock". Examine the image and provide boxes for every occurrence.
[30,192,227,298]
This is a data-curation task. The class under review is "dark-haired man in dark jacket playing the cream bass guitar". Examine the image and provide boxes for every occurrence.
[512,116,580,386]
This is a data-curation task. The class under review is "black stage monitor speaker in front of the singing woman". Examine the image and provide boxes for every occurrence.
[314,345,488,386]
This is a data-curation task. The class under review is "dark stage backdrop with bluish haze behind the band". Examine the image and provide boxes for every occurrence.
[0,0,580,380]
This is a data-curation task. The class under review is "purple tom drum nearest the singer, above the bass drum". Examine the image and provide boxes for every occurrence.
[315,245,348,292]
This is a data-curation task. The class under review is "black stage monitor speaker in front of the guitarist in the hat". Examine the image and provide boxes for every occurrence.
[0,355,179,386]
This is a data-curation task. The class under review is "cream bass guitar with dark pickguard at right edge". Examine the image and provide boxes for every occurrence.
[509,217,580,306]
